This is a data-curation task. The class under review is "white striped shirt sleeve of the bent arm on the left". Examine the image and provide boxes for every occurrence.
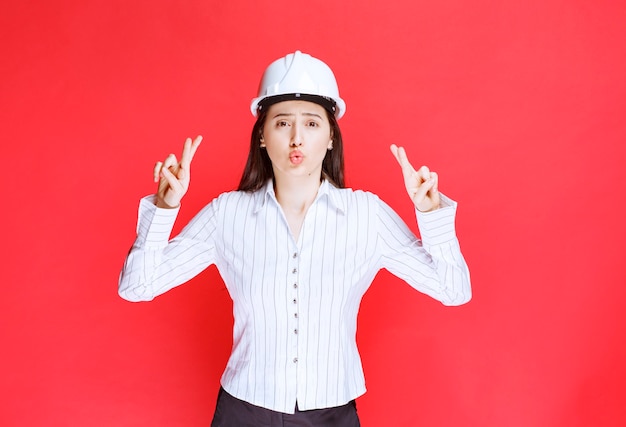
[118,196,216,301]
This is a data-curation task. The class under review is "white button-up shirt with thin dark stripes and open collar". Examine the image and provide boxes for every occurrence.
[119,181,471,413]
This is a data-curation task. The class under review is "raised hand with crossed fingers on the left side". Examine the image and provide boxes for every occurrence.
[154,135,202,209]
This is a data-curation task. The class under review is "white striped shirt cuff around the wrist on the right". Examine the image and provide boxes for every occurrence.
[415,193,457,246]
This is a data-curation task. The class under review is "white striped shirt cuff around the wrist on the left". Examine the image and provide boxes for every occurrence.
[135,194,180,248]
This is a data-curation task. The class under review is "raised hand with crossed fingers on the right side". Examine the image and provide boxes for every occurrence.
[389,144,440,212]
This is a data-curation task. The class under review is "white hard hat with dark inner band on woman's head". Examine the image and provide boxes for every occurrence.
[250,50,346,119]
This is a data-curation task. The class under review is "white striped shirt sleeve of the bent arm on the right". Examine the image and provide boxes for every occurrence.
[377,195,472,305]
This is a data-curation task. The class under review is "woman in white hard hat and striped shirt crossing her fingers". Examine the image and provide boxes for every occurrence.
[119,51,471,427]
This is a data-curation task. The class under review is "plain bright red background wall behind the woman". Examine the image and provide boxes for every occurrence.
[0,0,626,427]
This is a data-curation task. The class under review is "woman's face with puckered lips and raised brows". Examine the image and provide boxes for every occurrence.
[261,101,332,179]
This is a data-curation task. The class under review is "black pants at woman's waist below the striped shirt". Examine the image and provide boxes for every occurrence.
[211,388,361,427]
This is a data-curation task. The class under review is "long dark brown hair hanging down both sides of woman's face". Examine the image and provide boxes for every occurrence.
[237,108,345,192]
